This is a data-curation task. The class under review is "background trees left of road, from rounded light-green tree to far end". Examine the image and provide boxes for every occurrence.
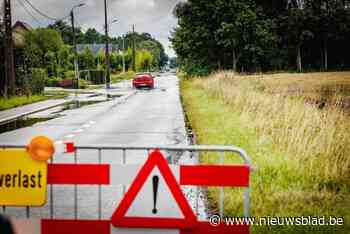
[25,21,168,76]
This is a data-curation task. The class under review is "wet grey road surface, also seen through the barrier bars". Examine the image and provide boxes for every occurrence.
[0,75,188,219]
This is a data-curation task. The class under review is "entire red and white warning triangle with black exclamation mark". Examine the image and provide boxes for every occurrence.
[111,150,197,229]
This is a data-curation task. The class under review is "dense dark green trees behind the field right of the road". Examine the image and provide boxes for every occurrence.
[171,0,350,73]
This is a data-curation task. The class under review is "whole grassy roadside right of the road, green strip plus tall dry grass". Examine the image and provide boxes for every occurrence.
[182,72,350,233]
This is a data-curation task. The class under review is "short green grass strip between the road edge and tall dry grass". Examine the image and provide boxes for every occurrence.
[181,80,350,234]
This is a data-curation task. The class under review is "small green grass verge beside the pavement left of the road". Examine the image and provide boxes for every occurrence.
[0,95,49,110]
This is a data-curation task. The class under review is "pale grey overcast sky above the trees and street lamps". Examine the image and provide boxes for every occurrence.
[12,0,181,56]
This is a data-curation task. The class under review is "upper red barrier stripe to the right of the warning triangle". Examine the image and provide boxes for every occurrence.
[180,165,249,187]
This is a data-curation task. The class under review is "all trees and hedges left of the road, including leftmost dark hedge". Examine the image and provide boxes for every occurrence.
[0,21,168,95]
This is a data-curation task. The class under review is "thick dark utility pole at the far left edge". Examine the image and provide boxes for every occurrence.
[4,0,16,97]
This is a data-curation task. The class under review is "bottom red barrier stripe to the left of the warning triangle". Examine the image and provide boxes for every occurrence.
[41,219,111,234]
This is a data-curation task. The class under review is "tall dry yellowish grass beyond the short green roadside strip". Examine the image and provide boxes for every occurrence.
[194,72,350,187]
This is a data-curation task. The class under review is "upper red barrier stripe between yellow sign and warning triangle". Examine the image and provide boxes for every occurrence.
[47,164,110,184]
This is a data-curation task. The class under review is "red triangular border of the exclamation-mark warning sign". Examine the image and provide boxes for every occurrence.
[111,150,197,229]
